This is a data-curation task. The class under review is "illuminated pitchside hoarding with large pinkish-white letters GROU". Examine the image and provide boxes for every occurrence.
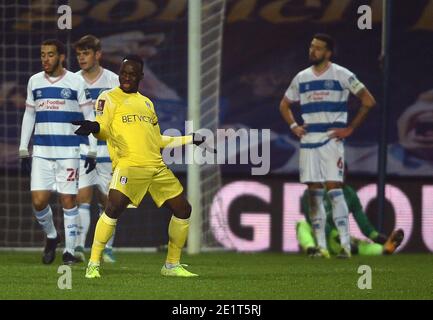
[209,176,433,252]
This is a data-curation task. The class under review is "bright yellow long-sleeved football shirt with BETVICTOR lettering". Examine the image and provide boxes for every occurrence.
[95,87,192,169]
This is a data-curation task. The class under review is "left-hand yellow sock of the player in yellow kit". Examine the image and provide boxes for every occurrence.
[90,212,117,264]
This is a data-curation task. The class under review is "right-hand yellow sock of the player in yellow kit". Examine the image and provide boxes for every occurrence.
[166,216,189,264]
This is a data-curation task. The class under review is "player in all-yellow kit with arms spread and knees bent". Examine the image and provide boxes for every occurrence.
[73,56,213,278]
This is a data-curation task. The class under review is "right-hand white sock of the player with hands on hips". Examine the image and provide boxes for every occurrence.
[328,189,350,252]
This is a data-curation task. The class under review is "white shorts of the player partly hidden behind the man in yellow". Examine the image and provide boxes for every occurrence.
[79,160,112,195]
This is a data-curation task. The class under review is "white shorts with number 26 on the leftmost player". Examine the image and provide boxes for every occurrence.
[30,157,80,194]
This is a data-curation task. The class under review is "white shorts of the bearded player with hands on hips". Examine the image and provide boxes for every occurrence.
[299,139,344,183]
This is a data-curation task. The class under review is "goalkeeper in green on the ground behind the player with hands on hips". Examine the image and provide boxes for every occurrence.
[296,165,404,258]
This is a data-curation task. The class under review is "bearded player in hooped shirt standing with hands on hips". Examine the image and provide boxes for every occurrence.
[280,34,376,258]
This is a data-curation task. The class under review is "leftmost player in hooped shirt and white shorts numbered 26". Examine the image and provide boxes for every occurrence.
[19,39,96,264]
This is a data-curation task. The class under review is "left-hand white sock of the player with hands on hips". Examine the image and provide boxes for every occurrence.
[309,189,327,249]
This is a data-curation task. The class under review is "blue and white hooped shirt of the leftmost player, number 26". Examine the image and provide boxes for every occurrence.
[26,69,92,159]
